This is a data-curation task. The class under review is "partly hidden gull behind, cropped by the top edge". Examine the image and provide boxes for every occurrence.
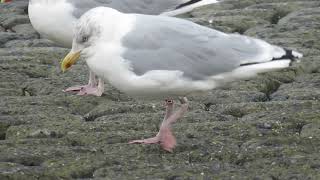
[28,0,217,95]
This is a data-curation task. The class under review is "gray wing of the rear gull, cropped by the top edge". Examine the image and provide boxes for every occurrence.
[67,0,190,18]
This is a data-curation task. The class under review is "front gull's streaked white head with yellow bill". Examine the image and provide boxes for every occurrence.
[61,7,120,71]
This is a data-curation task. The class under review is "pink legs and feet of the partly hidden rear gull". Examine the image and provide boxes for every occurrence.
[64,71,104,96]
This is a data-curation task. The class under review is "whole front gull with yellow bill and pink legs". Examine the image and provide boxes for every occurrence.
[62,7,302,151]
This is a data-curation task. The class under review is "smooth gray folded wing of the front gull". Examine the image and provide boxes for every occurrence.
[122,15,278,80]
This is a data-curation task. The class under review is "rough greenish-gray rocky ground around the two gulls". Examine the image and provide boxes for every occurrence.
[0,0,320,180]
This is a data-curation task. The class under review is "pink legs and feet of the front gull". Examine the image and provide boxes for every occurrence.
[129,97,188,152]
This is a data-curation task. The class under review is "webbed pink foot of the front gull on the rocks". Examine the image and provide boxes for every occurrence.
[129,128,177,152]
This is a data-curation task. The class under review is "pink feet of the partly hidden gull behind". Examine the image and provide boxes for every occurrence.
[64,85,103,96]
